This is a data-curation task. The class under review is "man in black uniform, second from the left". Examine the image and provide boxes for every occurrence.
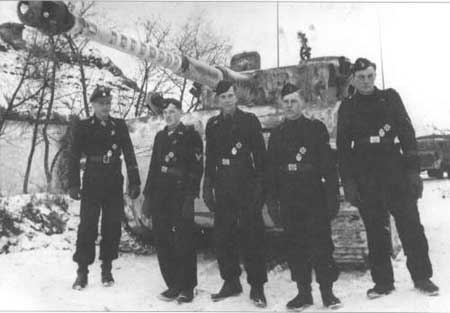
[144,99,203,303]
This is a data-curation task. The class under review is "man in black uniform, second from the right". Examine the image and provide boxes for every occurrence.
[266,83,341,310]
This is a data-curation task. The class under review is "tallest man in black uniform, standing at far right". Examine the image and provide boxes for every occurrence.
[337,58,439,298]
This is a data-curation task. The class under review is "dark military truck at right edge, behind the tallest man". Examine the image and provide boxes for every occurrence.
[417,134,450,178]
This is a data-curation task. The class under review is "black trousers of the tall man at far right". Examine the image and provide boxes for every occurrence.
[358,165,433,284]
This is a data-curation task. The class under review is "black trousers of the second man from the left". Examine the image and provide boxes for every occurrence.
[151,186,197,290]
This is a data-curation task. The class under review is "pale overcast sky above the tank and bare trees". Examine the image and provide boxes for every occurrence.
[0,1,450,129]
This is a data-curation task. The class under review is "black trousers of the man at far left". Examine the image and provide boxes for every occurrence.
[73,173,124,265]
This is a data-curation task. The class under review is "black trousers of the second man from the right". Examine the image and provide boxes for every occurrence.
[281,199,339,289]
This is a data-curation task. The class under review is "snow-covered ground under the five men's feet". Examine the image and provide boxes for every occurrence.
[0,180,450,312]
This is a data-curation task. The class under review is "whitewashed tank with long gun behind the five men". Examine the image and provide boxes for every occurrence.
[17,1,399,265]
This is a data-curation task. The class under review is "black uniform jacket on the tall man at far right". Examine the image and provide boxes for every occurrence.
[336,88,420,184]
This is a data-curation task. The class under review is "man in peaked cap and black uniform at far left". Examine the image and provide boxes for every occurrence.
[69,86,141,290]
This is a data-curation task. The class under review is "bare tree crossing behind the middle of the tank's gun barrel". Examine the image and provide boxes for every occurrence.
[135,13,232,117]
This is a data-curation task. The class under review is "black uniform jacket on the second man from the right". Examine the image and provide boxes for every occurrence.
[266,115,338,204]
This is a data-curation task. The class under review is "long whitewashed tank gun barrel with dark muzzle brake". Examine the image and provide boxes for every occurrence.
[17,1,249,88]
